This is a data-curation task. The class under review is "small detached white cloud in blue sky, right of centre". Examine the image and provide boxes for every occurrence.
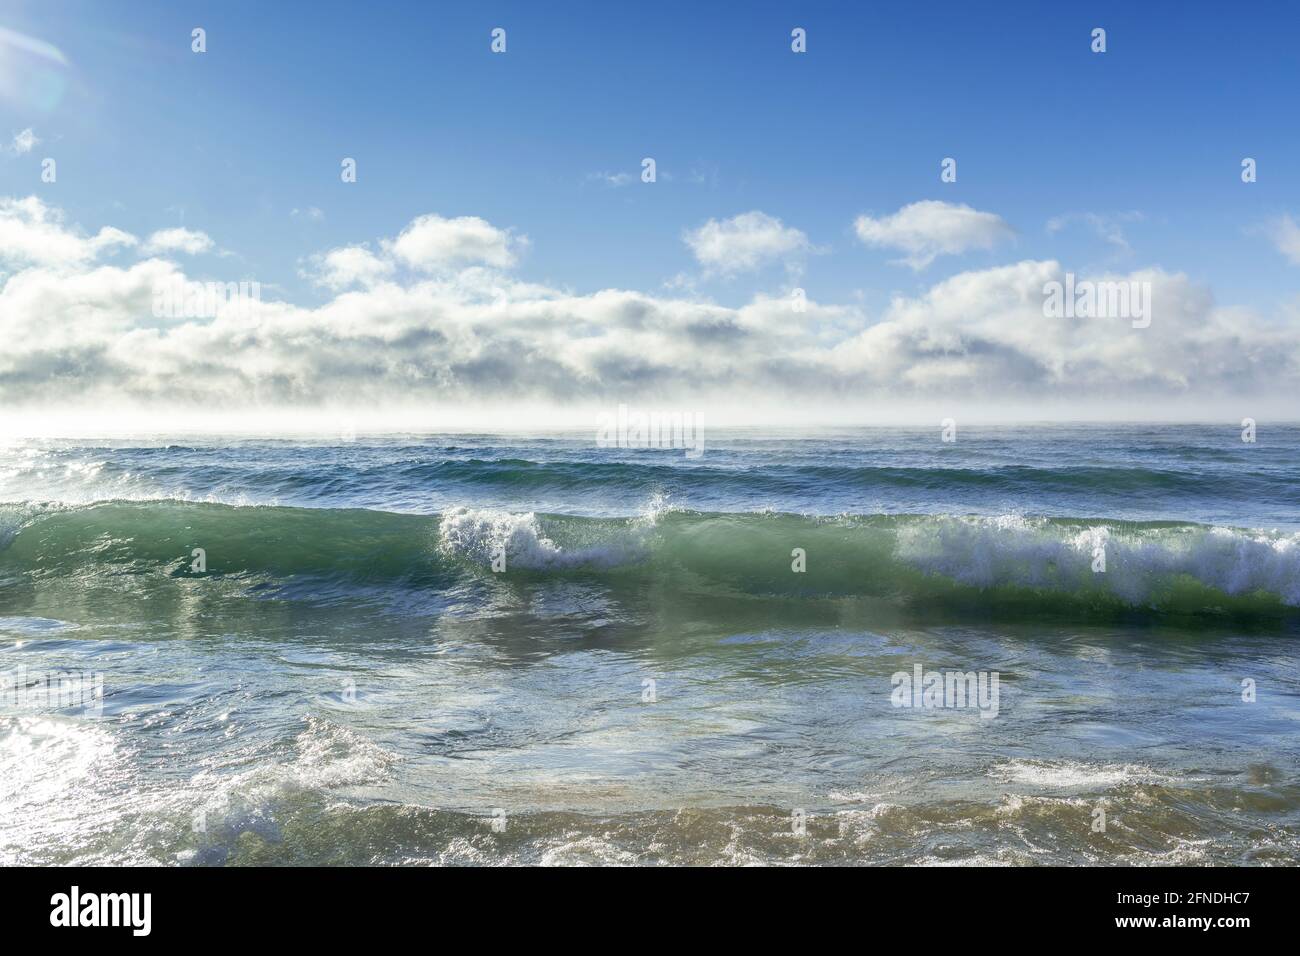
[853,199,1013,271]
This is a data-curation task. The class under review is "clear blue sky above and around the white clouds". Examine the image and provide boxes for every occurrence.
[0,0,1300,426]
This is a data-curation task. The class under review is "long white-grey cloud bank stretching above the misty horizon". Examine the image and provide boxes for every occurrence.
[0,199,1300,414]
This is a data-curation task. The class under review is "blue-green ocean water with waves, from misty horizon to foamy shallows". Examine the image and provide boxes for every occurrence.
[0,424,1300,865]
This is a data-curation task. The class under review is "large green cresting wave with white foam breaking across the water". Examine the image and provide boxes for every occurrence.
[0,501,1300,622]
